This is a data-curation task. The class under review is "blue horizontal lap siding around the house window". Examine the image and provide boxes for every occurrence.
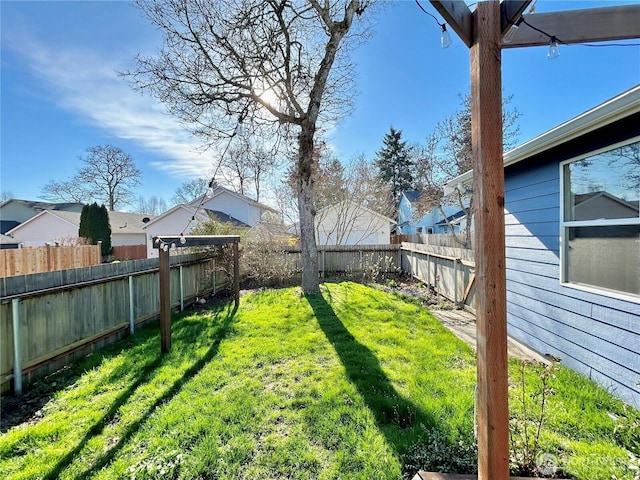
[505,149,640,407]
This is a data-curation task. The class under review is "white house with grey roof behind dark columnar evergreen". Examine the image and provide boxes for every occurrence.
[7,210,153,247]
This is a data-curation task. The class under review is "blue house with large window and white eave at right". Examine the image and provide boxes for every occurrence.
[449,86,640,407]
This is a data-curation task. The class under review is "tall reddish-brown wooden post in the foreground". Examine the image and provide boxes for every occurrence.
[471,0,509,480]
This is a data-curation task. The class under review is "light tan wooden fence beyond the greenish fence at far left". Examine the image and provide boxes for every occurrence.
[0,245,102,277]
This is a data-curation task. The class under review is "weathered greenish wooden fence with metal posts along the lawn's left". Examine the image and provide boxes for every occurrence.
[0,254,228,391]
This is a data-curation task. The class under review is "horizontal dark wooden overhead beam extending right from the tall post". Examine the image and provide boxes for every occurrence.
[502,5,640,48]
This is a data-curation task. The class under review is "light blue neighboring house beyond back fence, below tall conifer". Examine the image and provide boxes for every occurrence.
[396,190,466,235]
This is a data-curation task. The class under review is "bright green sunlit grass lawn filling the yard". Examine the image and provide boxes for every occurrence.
[0,282,640,480]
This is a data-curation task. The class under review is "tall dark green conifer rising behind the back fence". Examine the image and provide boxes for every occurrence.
[375,127,415,205]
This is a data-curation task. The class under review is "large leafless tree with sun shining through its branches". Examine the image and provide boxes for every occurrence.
[133,0,374,292]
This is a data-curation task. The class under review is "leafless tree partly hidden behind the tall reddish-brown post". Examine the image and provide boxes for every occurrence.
[416,94,520,248]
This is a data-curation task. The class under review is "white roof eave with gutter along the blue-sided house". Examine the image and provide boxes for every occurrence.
[444,85,640,195]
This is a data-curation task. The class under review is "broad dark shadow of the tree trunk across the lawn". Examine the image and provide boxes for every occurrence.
[306,294,438,457]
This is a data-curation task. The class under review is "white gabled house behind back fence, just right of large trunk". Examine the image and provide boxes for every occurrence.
[316,200,396,245]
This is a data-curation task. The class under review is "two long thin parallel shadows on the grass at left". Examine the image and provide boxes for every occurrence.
[44,304,238,479]
